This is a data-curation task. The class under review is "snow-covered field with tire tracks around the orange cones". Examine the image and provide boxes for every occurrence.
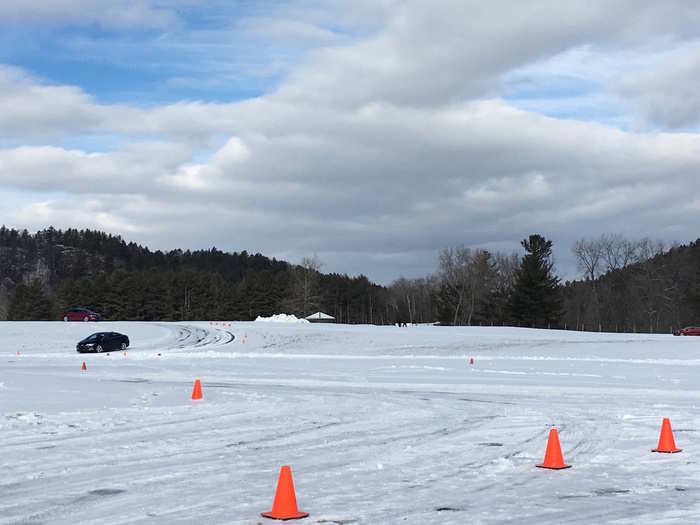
[0,322,700,524]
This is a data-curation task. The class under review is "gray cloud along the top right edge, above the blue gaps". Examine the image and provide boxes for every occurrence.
[281,0,700,106]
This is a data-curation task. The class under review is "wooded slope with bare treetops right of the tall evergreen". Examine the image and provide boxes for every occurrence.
[562,235,700,332]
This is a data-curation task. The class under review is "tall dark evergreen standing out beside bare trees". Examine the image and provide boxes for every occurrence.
[511,235,561,327]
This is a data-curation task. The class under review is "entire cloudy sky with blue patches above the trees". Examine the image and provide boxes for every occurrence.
[0,0,700,283]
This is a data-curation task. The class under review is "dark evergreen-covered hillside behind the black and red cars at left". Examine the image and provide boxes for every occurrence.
[0,226,388,324]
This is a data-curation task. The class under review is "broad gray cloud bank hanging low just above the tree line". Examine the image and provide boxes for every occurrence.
[0,95,700,279]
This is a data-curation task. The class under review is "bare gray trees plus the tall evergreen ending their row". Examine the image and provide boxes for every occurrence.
[389,234,562,327]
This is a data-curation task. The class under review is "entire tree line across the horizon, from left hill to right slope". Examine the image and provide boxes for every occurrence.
[0,227,700,332]
